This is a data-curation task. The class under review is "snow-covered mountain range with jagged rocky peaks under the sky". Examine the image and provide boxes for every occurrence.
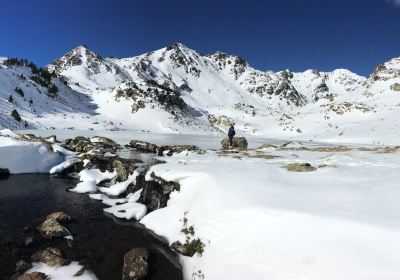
[0,44,400,143]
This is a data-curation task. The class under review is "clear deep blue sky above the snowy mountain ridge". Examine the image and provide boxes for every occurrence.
[0,0,400,75]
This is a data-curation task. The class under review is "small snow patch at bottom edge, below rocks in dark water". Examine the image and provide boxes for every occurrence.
[26,261,97,280]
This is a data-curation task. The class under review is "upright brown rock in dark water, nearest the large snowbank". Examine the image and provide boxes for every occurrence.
[122,248,149,280]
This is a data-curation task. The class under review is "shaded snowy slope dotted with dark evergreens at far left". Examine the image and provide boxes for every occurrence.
[0,58,101,128]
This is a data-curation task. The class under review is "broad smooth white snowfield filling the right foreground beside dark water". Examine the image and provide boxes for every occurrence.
[141,149,400,280]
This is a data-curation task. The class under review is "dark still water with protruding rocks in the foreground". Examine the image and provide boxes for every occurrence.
[0,174,182,280]
